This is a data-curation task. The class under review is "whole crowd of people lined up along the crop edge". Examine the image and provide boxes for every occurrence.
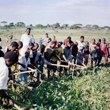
[0,28,110,104]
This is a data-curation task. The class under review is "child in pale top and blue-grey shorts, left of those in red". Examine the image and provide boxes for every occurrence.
[90,39,97,67]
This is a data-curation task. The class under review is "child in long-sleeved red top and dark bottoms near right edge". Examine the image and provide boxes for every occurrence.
[98,38,108,65]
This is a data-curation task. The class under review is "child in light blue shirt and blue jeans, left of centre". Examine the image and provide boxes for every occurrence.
[17,51,30,85]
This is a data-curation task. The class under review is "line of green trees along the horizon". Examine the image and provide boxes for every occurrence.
[0,21,110,30]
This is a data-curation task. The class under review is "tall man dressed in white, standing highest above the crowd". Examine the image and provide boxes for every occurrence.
[20,28,33,56]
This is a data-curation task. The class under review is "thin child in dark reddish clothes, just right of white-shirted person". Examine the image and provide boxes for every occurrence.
[84,41,89,65]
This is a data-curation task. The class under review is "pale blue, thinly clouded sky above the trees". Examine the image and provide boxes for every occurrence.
[0,0,110,26]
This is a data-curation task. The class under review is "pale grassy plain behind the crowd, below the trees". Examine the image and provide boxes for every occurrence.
[0,28,110,46]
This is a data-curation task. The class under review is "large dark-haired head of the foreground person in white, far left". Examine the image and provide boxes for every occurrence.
[4,51,18,67]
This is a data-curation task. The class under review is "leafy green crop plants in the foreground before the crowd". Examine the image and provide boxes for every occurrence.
[0,65,110,110]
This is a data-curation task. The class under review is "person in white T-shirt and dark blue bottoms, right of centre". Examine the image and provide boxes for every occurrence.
[77,36,85,65]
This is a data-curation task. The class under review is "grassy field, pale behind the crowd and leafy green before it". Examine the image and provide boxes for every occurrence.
[0,29,110,110]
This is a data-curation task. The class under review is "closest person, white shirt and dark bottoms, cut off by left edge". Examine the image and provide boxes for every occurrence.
[0,51,18,105]
